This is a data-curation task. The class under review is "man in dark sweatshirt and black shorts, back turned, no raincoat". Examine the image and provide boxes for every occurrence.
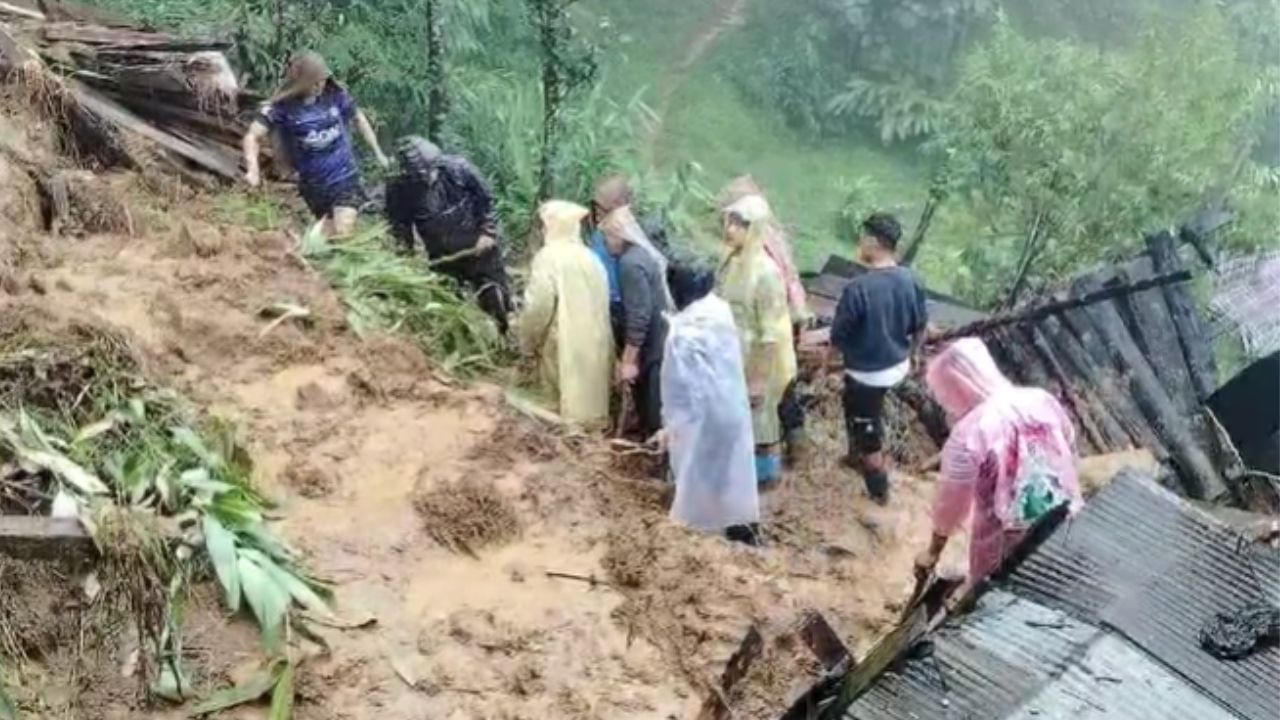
[831,213,928,505]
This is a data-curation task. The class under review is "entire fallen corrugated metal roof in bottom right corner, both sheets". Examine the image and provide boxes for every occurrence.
[846,473,1280,720]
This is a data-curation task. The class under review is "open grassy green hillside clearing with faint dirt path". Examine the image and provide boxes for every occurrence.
[584,0,925,268]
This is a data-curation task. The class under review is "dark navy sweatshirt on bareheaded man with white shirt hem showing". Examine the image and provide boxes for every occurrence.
[831,266,928,373]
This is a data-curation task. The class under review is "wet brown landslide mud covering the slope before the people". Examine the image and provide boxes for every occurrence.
[0,96,959,720]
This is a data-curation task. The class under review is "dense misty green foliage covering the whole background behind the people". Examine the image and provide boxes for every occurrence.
[87,0,1280,304]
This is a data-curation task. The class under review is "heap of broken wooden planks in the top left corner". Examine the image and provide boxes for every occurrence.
[0,0,259,186]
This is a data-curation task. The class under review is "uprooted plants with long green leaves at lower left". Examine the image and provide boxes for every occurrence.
[0,319,329,720]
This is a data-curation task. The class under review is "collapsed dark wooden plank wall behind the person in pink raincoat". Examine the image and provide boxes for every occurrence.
[810,231,1264,511]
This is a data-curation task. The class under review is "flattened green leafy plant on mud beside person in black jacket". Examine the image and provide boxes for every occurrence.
[301,223,504,375]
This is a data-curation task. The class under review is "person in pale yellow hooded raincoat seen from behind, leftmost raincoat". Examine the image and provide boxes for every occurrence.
[517,200,613,427]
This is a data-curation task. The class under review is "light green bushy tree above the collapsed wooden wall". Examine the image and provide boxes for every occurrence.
[933,8,1276,302]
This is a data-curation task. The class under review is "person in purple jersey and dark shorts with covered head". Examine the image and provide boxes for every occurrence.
[244,53,389,237]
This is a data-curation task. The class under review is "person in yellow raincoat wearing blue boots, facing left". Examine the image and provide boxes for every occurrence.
[716,195,796,484]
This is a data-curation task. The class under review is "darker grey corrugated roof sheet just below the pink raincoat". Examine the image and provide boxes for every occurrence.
[1011,474,1280,720]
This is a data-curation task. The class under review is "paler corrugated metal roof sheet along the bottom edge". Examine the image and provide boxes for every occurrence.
[846,591,1235,720]
